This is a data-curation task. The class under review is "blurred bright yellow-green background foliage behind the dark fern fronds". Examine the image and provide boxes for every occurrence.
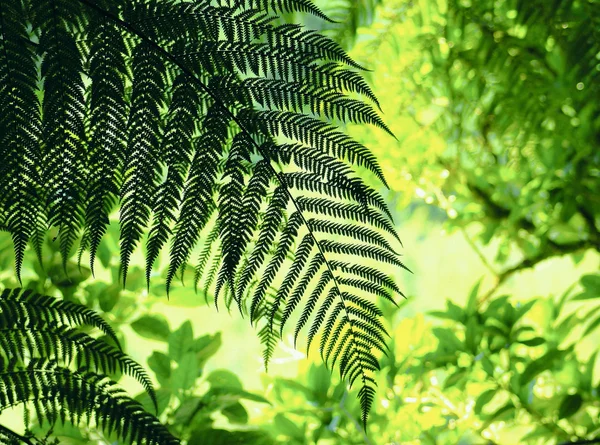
[0,0,600,445]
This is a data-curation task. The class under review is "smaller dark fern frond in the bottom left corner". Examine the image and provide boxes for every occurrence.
[0,289,179,444]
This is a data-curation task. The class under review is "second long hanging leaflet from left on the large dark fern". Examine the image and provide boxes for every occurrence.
[35,0,87,266]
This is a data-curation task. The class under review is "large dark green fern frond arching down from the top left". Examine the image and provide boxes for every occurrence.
[0,0,403,421]
